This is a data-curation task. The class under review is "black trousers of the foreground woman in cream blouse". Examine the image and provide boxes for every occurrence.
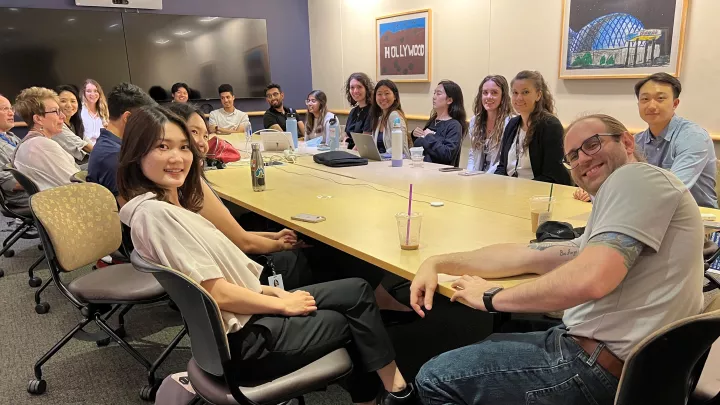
[228,274,395,402]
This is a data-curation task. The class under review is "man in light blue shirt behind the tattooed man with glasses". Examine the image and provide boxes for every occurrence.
[635,73,718,208]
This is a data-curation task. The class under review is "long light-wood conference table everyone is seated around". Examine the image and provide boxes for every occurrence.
[206,135,720,297]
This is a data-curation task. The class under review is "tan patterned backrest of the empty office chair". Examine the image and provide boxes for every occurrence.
[30,183,122,271]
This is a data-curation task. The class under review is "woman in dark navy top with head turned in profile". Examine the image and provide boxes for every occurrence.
[413,80,468,167]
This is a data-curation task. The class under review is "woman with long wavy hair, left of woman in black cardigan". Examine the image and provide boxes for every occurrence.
[467,75,513,173]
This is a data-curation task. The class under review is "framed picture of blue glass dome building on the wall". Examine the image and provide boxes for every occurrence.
[560,0,688,79]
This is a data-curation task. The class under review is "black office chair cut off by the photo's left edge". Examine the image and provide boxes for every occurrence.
[0,163,47,284]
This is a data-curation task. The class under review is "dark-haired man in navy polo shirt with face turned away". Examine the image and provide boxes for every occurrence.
[87,83,156,196]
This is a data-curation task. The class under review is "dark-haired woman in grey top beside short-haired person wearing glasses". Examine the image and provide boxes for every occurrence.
[50,84,93,161]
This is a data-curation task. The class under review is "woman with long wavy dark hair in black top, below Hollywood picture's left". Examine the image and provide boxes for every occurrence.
[345,73,375,149]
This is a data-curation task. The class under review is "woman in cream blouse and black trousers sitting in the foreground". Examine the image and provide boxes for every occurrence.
[118,107,416,404]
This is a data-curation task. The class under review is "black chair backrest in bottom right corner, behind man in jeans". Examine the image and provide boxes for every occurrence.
[615,296,720,405]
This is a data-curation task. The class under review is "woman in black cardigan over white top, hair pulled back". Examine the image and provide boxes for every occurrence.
[495,70,572,185]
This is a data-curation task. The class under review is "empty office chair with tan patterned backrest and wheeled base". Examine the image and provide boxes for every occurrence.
[27,183,186,400]
